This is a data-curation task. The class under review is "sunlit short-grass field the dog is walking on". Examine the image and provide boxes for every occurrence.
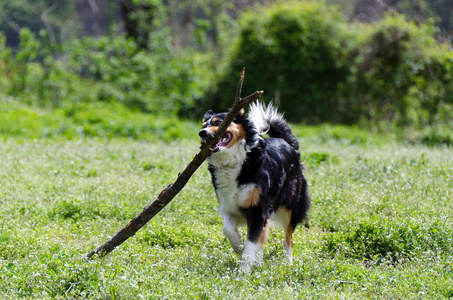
[0,127,453,299]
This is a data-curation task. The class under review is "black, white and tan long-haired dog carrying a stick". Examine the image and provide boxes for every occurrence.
[199,103,310,272]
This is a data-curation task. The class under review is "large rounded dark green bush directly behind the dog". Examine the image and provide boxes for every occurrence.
[213,3,348,122]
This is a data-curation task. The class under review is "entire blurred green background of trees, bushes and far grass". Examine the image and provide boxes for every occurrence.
[0,0,453,144]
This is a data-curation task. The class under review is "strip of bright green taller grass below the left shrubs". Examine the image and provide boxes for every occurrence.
[0,100,197,142]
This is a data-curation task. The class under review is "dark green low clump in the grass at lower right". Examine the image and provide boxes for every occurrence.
[324,217,453,261]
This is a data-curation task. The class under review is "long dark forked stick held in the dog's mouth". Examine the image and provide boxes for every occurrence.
[86,68,264,259]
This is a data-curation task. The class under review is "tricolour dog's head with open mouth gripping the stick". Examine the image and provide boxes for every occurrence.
[198,110,258,153]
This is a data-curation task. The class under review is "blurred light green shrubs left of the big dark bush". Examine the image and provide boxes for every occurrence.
[0,29,213,117]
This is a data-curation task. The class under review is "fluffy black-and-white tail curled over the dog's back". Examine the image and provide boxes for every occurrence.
[249,102,299,150]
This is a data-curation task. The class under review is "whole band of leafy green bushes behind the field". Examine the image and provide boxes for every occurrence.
[0,1,453,129]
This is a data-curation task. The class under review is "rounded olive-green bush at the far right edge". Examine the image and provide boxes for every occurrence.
[338,17,453,126]
